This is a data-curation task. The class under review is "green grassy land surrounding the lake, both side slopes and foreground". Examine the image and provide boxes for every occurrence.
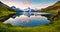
[0,1,60,32]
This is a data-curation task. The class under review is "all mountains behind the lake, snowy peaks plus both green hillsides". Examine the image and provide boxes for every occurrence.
[0,1,60,21]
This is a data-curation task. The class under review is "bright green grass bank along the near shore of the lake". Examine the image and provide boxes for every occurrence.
[0,20,60,32]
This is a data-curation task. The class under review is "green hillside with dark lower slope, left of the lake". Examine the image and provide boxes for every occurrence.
[0,1,16,22]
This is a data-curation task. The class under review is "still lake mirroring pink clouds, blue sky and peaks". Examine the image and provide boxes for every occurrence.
[3,12,50,26]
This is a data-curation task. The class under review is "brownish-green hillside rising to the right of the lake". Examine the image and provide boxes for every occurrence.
[37,1,60,20]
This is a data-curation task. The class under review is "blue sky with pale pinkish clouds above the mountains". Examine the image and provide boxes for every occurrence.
[0,0,58,9]
